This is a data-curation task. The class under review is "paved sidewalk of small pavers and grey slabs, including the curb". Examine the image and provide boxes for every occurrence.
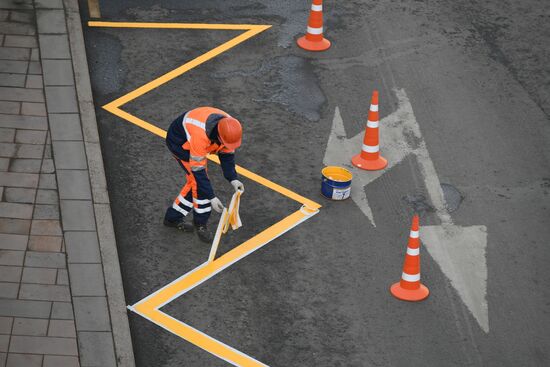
[0,0,133,367]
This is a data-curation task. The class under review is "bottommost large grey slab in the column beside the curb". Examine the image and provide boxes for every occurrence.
[78,331,116,367]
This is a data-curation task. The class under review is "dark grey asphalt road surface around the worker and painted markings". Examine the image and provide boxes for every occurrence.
[81,0,550,367]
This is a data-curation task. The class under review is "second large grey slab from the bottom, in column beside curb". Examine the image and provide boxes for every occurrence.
[73,297,111,331]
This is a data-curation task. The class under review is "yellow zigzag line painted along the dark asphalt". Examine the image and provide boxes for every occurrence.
[88,22,321,367]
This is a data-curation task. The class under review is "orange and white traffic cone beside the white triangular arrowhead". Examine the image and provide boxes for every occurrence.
[390,214,430,302]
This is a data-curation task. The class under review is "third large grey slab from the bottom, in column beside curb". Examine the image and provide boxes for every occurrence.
[69,263,105,297]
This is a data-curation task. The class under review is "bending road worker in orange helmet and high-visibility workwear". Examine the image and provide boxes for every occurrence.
[164,107,244,243]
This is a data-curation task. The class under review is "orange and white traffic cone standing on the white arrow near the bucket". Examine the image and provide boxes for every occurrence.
[351,90,388,171]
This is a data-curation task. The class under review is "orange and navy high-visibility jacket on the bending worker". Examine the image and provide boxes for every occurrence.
[166,107,237,199]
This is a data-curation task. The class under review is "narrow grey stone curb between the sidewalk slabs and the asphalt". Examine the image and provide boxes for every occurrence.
[63,0,135,367]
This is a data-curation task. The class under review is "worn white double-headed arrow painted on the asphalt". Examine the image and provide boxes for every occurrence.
[323,89,489,332]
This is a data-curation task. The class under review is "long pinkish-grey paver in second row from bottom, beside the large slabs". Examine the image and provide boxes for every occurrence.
[10,336,78,356]
